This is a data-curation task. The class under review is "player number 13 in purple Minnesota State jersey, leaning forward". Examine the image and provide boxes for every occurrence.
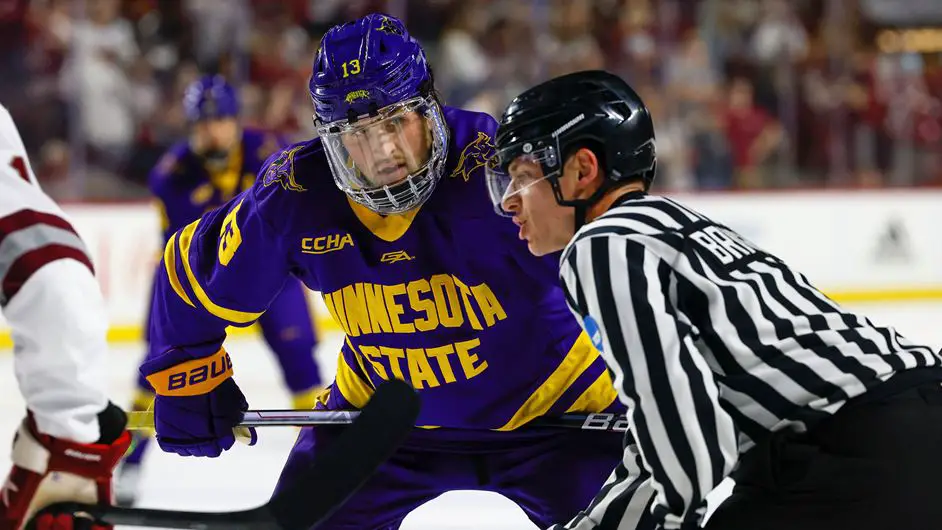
[141,14,622,530]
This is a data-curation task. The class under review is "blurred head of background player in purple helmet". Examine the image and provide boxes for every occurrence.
[183,75,240,170]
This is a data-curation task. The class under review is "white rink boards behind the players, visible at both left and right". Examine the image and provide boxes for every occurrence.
[0,190,942,336]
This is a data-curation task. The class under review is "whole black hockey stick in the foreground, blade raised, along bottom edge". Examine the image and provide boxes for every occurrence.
[32,381,419,530]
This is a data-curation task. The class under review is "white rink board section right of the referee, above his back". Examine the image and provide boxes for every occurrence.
[677,190,942,298]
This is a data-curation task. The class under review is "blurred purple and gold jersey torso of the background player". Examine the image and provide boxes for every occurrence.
[148,129,285,242]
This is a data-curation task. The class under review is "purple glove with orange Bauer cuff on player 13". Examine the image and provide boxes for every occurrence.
[141,348,257,457]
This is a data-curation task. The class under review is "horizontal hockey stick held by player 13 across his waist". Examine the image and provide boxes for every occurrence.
[128,410,628,432]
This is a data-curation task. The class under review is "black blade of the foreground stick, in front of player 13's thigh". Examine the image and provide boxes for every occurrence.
[267,379,420,530]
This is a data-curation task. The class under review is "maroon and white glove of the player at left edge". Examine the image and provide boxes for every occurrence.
[0,403,131,530]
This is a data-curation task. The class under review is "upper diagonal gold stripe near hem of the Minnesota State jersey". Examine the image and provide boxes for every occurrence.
[497,331,599,431]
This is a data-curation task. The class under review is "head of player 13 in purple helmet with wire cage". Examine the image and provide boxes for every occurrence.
[310,14,448,215]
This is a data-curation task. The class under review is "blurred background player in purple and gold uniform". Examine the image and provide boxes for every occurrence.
[116,75,323,505]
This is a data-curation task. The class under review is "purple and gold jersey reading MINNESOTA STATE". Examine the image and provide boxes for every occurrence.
[152,108,618,430]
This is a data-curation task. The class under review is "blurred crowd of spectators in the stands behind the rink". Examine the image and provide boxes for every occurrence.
[0,0,942,200]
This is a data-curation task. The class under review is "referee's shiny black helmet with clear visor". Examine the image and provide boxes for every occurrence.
[488,70,657,217]
